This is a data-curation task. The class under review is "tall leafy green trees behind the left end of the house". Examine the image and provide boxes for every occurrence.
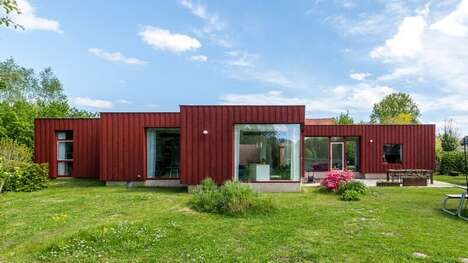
[0,59,97,147]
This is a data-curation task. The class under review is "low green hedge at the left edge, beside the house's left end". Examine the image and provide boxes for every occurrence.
[0,162,49,192]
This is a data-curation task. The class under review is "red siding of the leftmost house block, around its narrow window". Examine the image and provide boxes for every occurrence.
[34,119,99,178]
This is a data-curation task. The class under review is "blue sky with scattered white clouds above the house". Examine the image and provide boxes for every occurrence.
[0,0,468,134]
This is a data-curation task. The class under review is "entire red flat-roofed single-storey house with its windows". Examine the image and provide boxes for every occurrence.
[35,105,435,191]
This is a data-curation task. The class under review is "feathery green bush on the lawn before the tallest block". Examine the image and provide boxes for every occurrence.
[190,178,274,215]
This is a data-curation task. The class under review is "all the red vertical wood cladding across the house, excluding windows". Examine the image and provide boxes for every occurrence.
[34,105,435,185]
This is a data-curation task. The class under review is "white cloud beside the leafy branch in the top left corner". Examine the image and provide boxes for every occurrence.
[11,0,63,33]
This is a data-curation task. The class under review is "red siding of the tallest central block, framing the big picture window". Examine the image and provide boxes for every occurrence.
[180,106,305,185]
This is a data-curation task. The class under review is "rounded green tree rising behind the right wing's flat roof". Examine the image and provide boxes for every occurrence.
[370,92,421,124]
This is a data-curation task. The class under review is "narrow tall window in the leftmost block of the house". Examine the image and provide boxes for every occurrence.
[56,131,73,176]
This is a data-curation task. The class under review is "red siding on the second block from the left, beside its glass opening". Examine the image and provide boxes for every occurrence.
[100,112,180,181]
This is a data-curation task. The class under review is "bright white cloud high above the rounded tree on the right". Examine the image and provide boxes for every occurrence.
[371,16,426,59]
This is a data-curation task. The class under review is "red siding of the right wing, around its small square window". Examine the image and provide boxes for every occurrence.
[304,124,436,173]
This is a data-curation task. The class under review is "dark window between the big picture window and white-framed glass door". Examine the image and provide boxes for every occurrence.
[304,137,329,172]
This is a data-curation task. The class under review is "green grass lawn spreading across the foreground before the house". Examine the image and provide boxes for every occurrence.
[0,180,468,262]
